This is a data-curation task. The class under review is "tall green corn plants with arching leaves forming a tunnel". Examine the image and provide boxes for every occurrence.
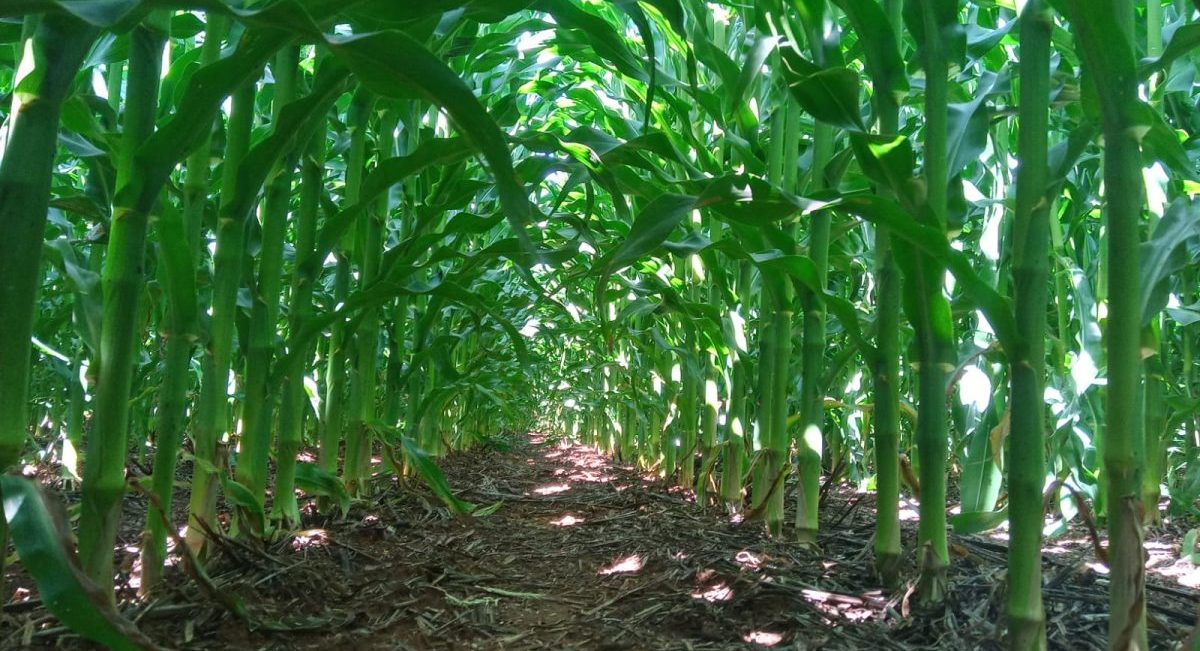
[0,0,1200,649]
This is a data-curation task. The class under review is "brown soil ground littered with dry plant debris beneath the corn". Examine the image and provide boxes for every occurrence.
[0,435,1200,651]
